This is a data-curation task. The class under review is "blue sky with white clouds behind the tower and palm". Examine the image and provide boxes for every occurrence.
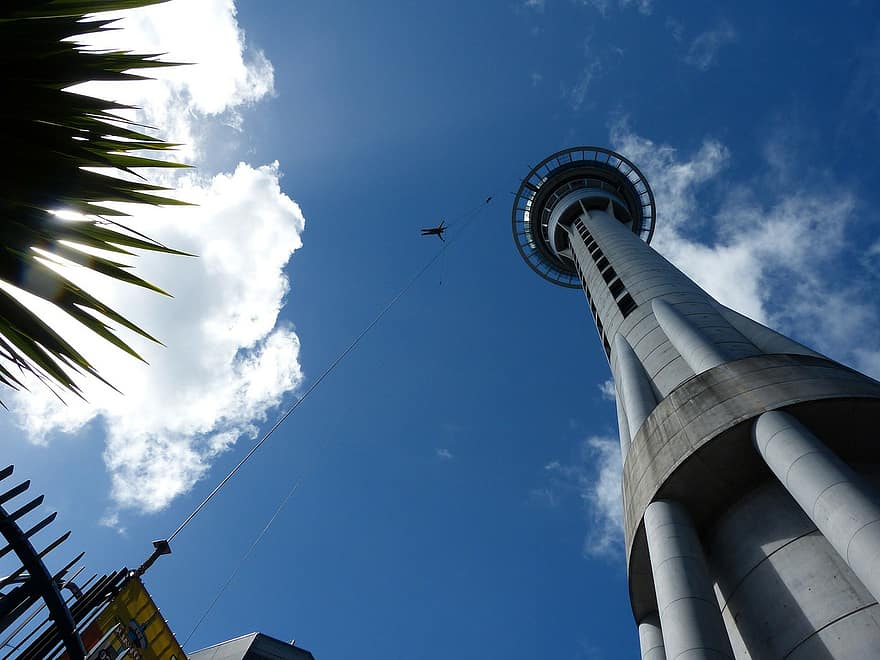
[2,0,880,660]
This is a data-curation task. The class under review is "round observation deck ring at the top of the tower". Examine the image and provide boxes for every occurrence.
[512,147,656,289]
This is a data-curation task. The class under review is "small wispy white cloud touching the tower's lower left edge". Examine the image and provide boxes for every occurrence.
[529,436,623,558]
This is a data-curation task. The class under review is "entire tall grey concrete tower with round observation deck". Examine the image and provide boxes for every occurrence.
[513,147,880,660]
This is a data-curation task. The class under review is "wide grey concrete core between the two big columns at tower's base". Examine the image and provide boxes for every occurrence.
[705,475,880,658]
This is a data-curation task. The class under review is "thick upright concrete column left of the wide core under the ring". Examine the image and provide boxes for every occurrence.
[645,500,733,660]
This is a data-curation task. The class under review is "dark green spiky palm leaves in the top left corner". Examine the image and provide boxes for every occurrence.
[0,0,191,402]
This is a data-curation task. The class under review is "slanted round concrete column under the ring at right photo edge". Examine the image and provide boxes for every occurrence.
[753,410,880,601]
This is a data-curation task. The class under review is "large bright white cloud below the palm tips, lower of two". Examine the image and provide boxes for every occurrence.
[12,164,304,511]
